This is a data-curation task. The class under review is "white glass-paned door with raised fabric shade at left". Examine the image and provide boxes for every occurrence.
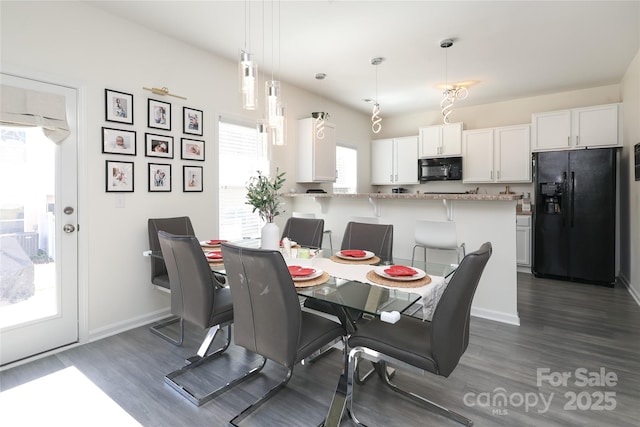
[0,74,78,365]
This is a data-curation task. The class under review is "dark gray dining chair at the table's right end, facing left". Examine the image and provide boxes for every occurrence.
[346,242,492,426]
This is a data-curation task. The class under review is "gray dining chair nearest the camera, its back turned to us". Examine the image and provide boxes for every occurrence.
[222,243,346,425]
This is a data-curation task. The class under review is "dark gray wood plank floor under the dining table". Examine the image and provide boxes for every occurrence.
[0,273,640,427]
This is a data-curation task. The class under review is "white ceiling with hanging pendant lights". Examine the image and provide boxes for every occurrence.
[87,0,640,116]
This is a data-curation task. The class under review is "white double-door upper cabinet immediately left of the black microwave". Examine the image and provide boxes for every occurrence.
[371,136,418,185]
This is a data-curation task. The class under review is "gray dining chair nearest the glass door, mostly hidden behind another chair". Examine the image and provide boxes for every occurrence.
[147,216,195,345]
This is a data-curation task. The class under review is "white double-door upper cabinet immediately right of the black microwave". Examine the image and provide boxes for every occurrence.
[462,125,531,183]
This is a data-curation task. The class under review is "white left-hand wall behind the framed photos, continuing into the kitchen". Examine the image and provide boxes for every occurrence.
[0,1,369,338]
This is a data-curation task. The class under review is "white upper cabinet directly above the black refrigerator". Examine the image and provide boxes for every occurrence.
[532,104,622,151]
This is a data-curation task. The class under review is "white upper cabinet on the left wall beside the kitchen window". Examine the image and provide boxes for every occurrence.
[296,118,336,182]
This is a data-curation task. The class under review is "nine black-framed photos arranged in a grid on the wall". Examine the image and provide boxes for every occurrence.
[102,89,205,193]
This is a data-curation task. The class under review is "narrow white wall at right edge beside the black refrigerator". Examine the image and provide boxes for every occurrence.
[620,50,640,304]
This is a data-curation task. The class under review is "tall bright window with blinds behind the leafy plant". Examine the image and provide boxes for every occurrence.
[218,117,269,239]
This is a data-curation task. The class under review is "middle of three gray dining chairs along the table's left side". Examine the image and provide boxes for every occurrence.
[158,231,266,406]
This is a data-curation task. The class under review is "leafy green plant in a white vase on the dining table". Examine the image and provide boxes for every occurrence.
[245,169,285,249]
